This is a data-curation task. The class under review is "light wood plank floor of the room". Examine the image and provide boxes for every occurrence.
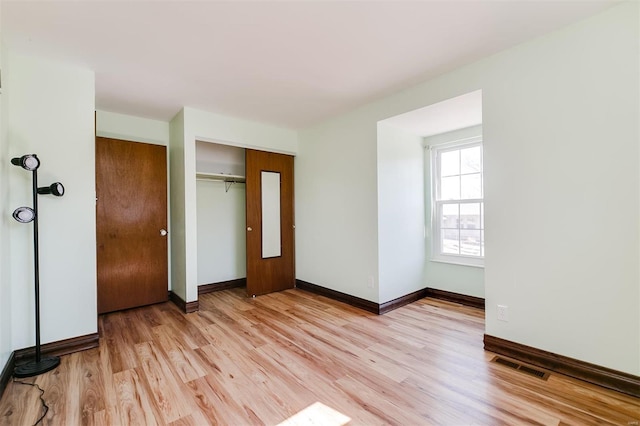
[0,289,640,426]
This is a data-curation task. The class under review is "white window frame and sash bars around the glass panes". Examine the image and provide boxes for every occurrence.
[429,136,484,268]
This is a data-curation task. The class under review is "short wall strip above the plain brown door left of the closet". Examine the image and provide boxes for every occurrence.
[96,110,169,145]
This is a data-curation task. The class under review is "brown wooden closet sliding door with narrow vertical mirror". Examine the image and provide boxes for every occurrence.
[246,149,295,296]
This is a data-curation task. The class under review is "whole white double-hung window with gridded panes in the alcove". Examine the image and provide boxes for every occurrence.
[431,137,484,266]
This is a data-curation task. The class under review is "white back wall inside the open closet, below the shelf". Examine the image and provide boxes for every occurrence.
[196,180,247,285]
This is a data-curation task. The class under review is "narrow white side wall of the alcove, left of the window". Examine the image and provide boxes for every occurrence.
[377,121,425,303]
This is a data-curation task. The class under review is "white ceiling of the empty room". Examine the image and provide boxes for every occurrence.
[1,0,616,128]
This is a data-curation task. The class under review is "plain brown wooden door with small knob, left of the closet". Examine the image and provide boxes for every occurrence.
[96,137,168,314]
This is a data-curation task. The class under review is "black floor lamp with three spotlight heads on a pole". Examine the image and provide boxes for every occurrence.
[11,154,64,377]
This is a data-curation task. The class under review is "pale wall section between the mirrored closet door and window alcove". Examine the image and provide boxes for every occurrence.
[295,112,379,303]
